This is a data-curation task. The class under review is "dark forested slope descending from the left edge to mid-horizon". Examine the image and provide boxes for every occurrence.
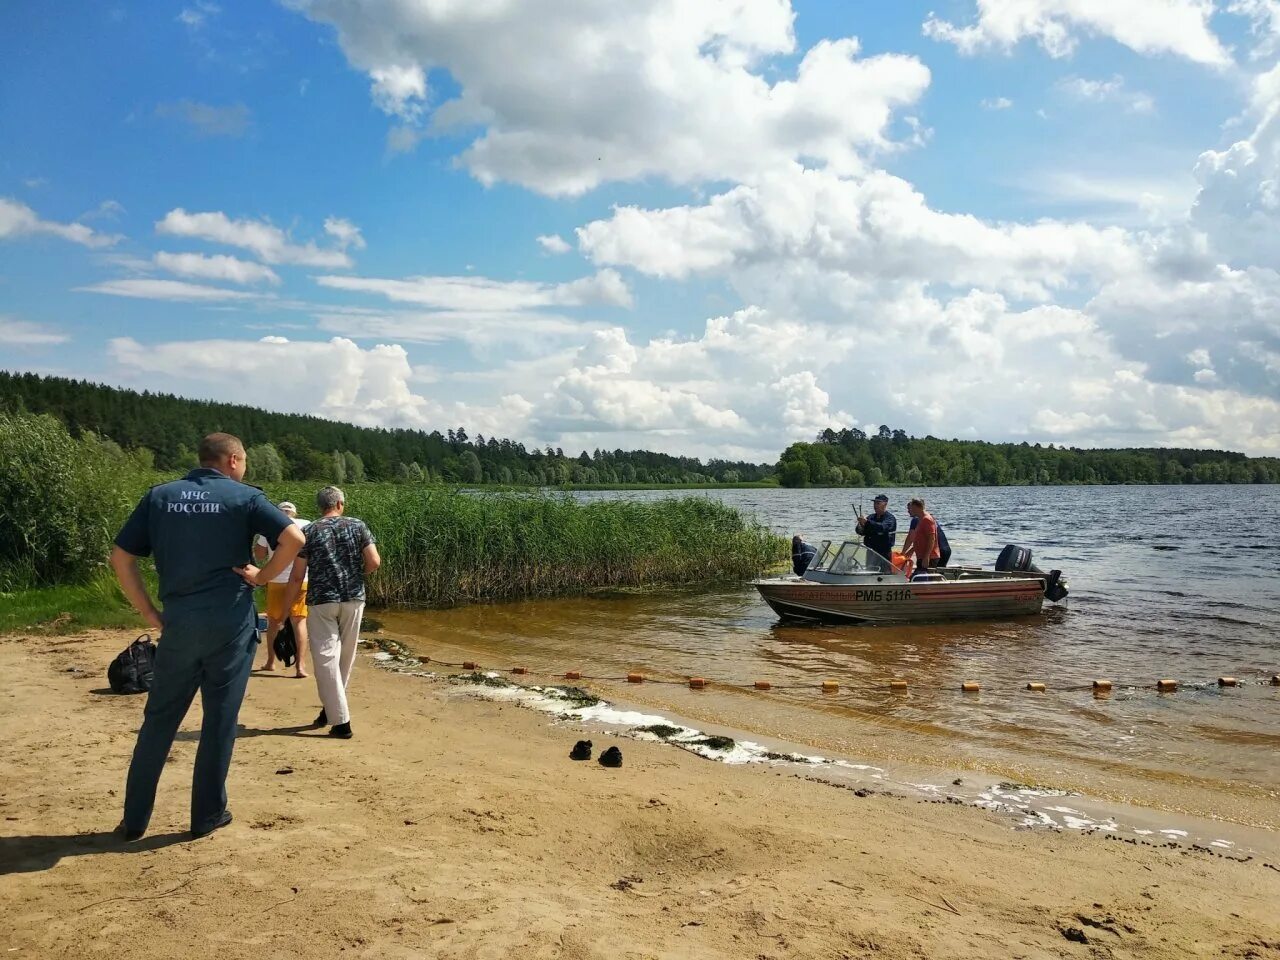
[0,371,773,486]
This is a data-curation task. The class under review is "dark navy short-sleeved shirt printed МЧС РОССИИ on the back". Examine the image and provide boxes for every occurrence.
[115,467,291,611]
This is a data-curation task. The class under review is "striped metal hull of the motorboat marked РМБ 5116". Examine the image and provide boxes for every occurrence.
[755,577,1044,623]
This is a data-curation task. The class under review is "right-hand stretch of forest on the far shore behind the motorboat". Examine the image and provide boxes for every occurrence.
[777,426,1280,486]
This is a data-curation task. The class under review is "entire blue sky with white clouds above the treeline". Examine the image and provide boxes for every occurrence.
[0,0,1280,460]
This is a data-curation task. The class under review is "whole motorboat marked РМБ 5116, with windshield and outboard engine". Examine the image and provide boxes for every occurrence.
[754,540,1068,623]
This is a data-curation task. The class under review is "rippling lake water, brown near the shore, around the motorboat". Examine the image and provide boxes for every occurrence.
[379,486,1280,828]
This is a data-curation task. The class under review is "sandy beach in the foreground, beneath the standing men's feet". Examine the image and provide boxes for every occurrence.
[0,632,1280,960]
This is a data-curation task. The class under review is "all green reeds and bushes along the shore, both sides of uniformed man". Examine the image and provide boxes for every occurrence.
[0,415,786,630]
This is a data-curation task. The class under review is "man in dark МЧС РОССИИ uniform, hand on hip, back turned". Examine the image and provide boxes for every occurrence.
[111,434,303,840]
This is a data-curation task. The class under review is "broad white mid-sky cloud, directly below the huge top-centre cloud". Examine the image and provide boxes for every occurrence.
[577,168,1138,302]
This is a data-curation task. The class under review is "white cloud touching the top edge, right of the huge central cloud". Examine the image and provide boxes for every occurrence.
[924,0,1230,67]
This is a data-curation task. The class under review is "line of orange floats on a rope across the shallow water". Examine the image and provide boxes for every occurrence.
[363,640,1280,696]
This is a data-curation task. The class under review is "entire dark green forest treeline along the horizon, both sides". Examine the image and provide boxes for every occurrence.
[0,371,1280,486]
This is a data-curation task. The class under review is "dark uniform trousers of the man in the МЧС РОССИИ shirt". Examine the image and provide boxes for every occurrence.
[124,611,257,833]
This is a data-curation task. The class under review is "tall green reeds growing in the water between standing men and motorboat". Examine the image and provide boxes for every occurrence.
[271,484,786,607]
